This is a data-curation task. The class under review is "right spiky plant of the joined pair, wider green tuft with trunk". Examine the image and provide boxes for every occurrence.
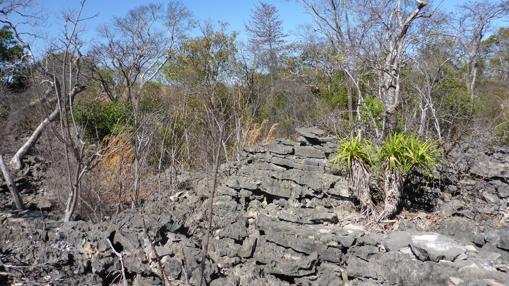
[377,133,441,221]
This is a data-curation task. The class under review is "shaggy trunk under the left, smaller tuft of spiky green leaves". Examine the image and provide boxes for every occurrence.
[348,160,376,218]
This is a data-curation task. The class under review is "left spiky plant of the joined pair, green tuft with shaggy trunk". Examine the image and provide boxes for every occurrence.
[332,136,376,217]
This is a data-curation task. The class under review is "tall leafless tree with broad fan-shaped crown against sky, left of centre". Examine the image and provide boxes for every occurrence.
[88,1,191,206]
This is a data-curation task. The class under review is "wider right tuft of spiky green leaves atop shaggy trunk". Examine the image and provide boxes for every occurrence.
[377,133,441,176]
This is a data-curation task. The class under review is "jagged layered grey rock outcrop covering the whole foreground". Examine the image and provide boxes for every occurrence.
[0,128,509,286]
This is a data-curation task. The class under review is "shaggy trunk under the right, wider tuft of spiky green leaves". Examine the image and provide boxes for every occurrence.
[376,167,403,222]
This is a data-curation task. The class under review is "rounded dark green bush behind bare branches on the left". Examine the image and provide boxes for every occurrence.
[74,101,132,142]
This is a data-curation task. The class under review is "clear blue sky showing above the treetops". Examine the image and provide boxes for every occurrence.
[15,0,500,51]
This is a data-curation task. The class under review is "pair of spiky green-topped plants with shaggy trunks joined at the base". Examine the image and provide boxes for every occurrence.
[332,133,442,221]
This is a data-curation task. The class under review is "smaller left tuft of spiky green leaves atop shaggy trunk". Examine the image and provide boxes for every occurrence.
[331,135,376,173]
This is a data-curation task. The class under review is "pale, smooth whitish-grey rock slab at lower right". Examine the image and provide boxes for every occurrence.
[410,232,466,262]
